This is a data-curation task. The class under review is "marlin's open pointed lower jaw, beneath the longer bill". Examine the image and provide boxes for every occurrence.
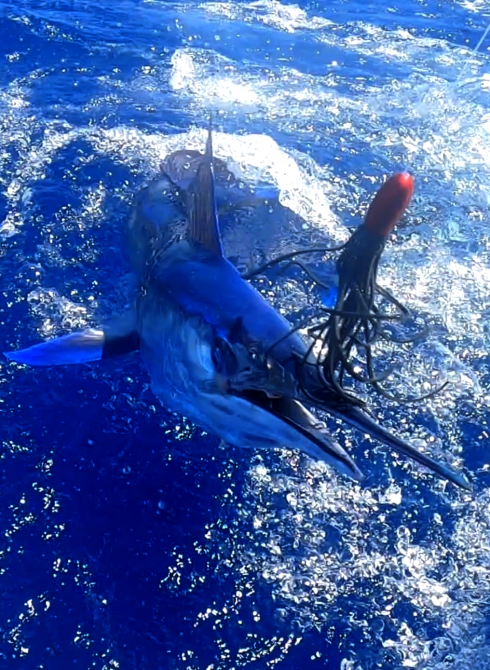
[234,390,364,481]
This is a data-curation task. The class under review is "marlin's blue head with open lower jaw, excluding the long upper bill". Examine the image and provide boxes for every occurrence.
[137,210,362,479]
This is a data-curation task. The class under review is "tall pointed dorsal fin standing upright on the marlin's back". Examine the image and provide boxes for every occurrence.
[188,119,223,257]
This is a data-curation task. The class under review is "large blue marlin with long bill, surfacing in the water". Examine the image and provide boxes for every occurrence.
[5,129,469,489]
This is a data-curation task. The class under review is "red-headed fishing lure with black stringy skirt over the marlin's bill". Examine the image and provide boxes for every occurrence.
[243,171,448,404]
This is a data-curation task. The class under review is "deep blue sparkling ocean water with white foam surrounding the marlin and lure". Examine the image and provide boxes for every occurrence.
[0,0,490,670]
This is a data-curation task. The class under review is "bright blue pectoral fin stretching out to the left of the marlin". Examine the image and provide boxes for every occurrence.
[4,328,139,367]
